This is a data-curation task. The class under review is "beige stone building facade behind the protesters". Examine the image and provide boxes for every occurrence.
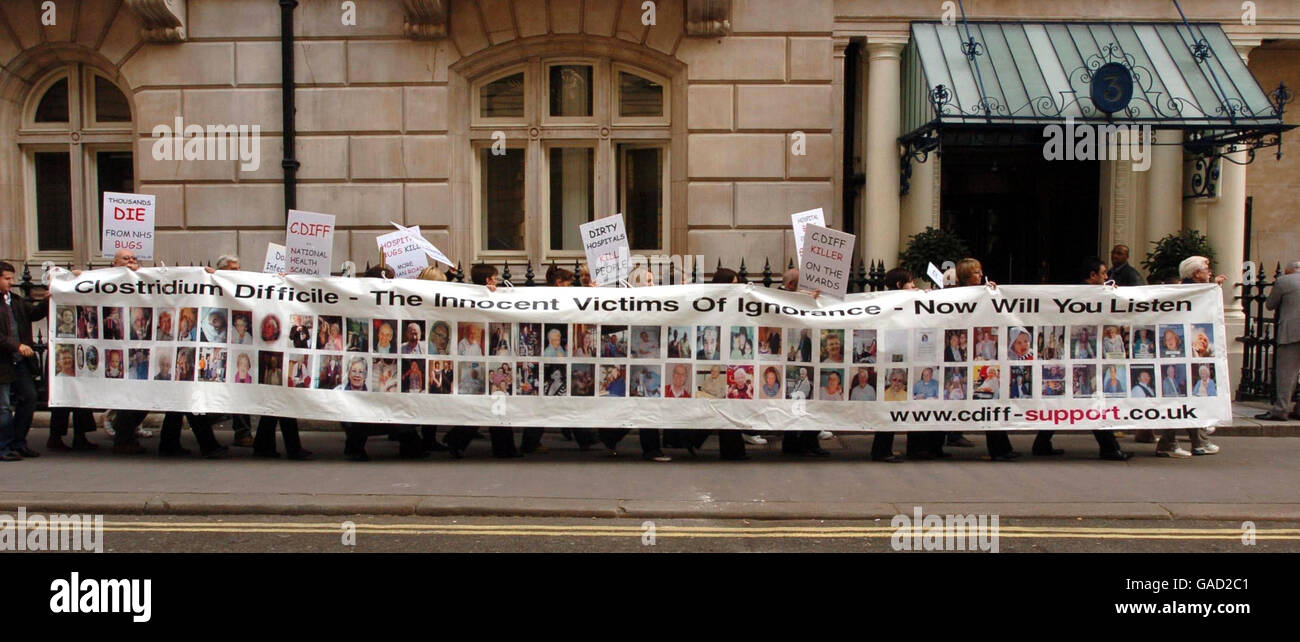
[0,0,1300,298]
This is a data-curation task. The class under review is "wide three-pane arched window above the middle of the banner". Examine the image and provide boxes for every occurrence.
[469,57,671,259]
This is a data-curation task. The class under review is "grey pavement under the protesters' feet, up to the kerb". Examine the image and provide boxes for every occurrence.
[0,421,1300,524]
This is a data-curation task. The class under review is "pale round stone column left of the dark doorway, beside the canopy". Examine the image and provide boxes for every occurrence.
[858,40,904,265]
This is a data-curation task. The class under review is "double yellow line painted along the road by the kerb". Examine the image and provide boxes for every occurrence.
[104,520,1300,541]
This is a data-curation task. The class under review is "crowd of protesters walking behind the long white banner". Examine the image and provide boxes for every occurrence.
[0,246,1274,463]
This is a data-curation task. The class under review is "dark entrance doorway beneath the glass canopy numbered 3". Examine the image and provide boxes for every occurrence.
[940,129,1105,283]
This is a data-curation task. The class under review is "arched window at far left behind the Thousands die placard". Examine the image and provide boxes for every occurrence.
[18,65,135,261]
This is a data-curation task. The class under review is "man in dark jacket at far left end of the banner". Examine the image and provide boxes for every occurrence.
[0,261,49,461]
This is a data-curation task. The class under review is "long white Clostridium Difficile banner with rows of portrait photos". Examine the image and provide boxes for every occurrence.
[49,268,1231,430]
